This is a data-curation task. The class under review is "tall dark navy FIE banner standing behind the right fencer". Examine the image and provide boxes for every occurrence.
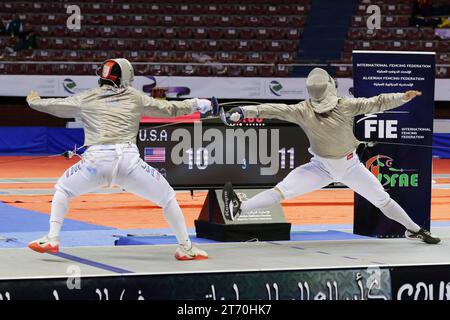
[353,51,435,237]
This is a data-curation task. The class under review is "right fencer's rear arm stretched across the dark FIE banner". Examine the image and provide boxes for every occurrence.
[340,90,422,116]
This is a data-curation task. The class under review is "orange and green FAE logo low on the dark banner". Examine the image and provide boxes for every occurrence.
[366,155,419,189]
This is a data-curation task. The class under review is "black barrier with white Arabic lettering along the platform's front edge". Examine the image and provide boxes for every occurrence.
[0,264,450,301]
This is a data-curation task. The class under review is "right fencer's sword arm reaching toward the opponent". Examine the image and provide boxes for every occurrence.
[230,103,303,123]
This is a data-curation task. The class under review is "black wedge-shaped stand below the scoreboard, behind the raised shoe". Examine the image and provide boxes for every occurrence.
[195,189,291,242]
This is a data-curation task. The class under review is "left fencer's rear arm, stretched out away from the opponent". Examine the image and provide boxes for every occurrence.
[27,91,81,118]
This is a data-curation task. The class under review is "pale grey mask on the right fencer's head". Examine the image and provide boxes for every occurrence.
[306,68,338,113]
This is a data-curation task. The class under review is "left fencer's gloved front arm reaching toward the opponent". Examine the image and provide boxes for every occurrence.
[140,90,211,118]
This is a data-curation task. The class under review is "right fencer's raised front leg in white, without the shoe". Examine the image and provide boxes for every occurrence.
[241,159,332,212]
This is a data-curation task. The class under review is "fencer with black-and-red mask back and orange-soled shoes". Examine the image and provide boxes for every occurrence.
[27,59,211,260]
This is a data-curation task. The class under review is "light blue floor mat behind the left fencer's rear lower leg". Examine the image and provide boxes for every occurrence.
[0,202,114,233]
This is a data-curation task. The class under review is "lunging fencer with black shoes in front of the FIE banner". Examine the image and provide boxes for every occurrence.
[224,68,440,244]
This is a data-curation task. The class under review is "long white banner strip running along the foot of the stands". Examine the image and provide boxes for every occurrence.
[0,75,450,101]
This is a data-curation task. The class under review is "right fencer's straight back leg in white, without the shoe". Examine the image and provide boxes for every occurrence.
[341,162,420,232]
